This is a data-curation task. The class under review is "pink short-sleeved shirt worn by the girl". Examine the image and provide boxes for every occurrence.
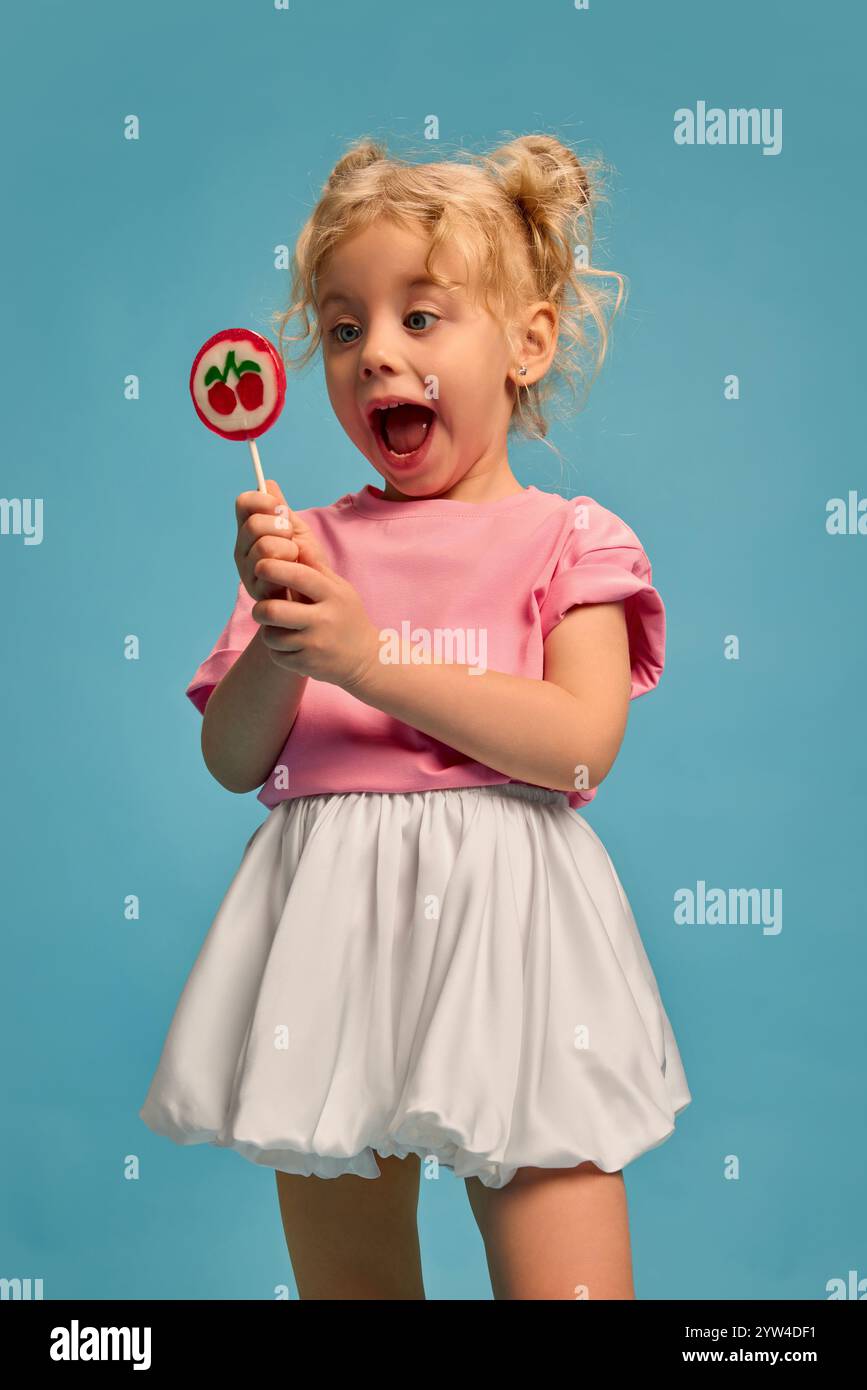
[186,484,666,809]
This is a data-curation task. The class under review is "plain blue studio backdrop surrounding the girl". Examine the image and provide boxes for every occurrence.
[0,0,867,1300]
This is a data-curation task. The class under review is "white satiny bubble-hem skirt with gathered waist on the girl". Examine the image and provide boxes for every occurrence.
[139,784,692,1187]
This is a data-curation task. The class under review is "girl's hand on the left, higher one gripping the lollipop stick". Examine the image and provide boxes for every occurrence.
[235,478,328,603]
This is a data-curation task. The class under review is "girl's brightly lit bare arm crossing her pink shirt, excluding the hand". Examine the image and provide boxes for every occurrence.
[345,600,632,791]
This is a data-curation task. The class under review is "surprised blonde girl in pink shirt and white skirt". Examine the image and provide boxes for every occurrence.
[140,135,691,1298]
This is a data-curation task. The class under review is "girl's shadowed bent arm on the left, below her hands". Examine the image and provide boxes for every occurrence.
[201,627,308,792]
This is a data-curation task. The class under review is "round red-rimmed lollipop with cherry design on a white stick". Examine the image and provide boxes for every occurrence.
[190,328,286,492]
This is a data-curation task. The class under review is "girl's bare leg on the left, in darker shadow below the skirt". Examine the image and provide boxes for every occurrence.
[275,1154,425,1300]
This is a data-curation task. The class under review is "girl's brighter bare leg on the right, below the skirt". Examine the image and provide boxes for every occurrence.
[465,1163,635,1298]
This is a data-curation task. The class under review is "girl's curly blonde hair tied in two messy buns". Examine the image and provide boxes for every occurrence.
[274,135,625,450]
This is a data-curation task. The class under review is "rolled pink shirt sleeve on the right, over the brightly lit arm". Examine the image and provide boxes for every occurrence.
[539,498,666,699]
